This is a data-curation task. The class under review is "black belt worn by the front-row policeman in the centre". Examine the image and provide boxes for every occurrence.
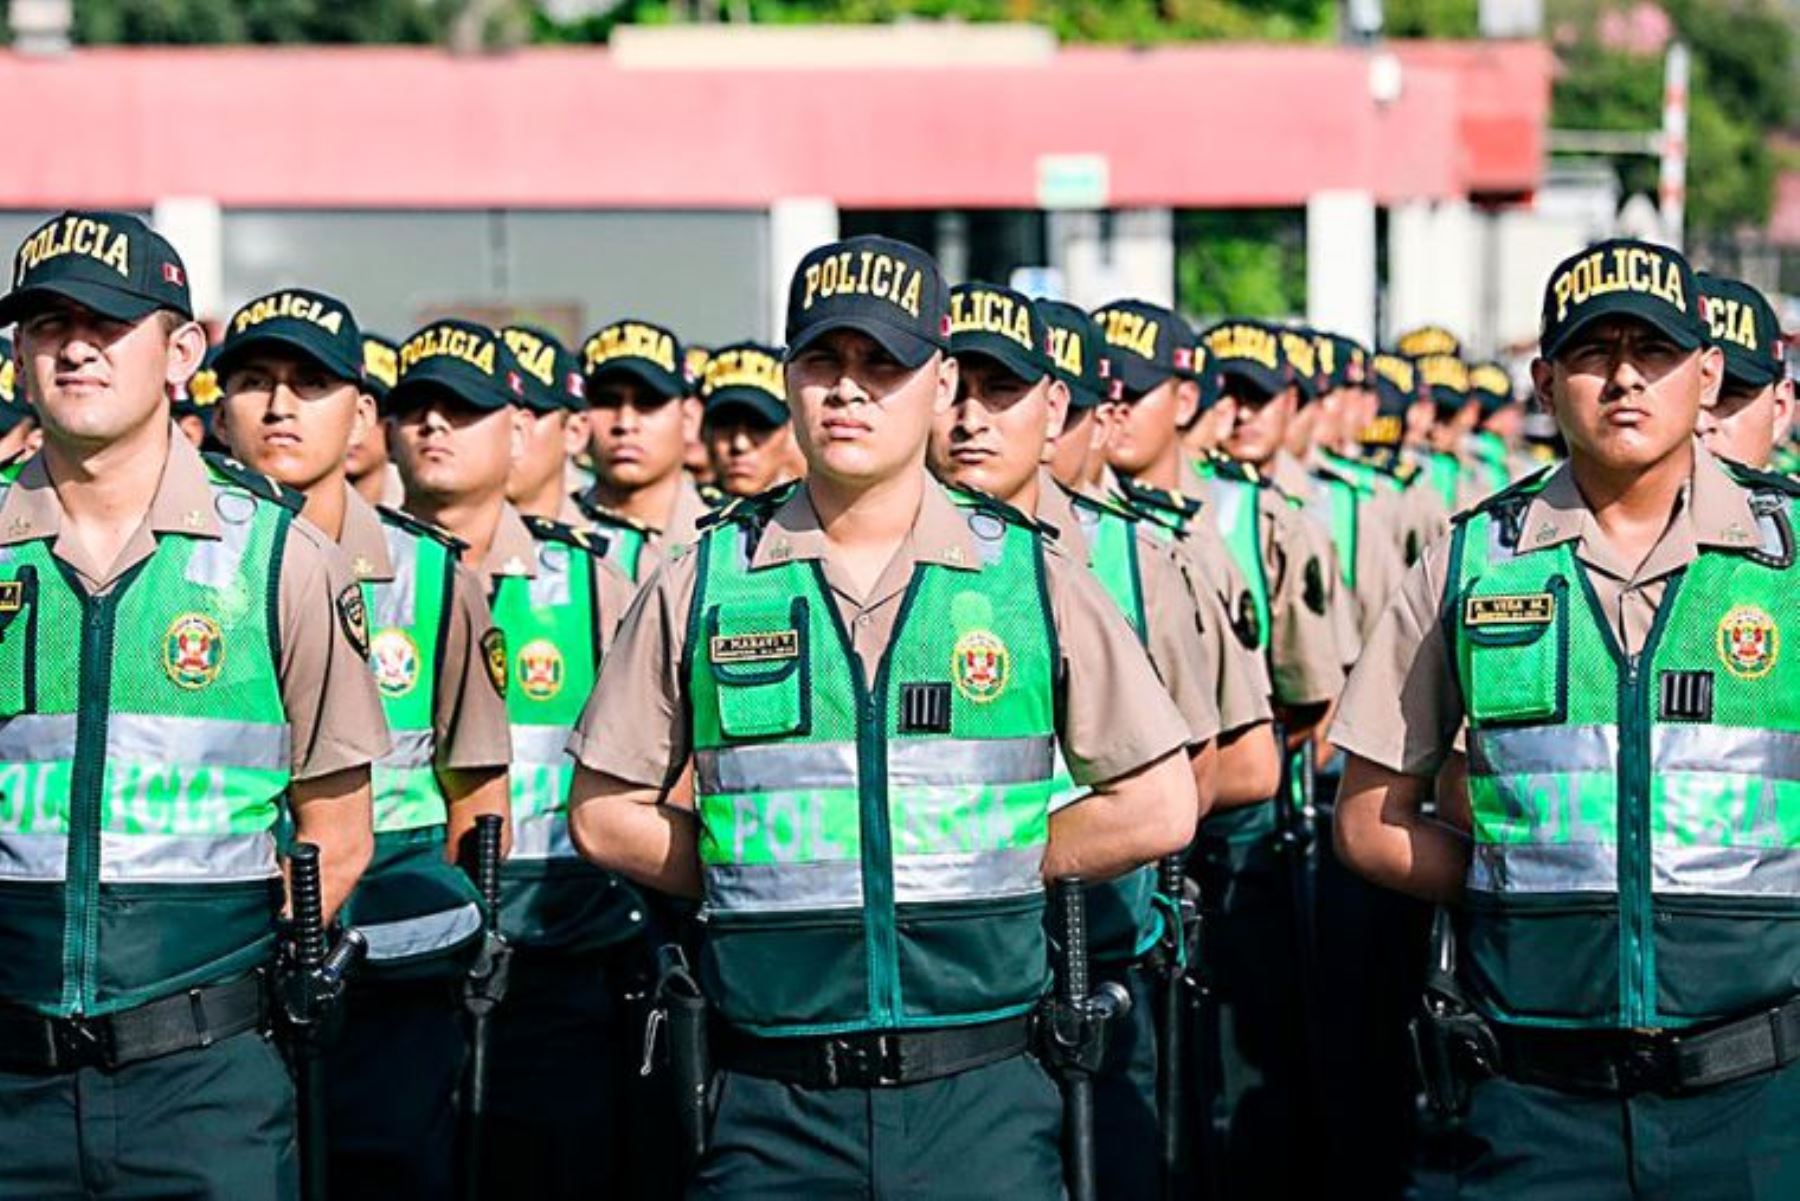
[716,1014,1037,1088]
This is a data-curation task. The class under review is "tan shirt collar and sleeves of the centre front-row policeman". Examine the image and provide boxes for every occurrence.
[569,481,1190,799]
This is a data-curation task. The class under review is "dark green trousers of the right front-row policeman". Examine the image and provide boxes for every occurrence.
[1456,1064,1800,1201]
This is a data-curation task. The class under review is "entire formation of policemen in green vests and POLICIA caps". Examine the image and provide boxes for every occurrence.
[0,212,1800,1201]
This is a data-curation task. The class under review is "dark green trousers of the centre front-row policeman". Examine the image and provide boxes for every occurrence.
[688,1055,1064,1201]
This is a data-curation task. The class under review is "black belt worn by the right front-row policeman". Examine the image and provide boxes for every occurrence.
[1494,996,1800,1097]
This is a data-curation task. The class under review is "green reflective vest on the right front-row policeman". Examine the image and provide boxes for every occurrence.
[1444,475,1800,1026]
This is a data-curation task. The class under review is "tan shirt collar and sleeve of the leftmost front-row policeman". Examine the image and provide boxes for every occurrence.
[0,427,389,780]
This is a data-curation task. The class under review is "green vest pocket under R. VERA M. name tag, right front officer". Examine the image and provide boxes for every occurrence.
[1458,576,1570,724]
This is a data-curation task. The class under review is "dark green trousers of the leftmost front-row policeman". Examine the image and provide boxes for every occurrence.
[0,1034,301,1201]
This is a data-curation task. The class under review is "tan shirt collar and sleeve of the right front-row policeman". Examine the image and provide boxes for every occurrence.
[1330,443,1757,776]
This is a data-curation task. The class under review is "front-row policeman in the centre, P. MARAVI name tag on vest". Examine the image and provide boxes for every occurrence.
[571,238,1197,1199]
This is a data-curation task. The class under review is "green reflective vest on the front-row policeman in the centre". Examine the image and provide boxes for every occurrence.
[688,490,1058,1034]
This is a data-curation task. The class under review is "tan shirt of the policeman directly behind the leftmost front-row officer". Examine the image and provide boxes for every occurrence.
[338,488,513,771]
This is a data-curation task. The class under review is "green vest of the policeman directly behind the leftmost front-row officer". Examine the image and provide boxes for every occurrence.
[344,508,481,978]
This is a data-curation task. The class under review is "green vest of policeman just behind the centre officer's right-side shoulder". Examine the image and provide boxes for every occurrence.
[1057,493,1163,963]
